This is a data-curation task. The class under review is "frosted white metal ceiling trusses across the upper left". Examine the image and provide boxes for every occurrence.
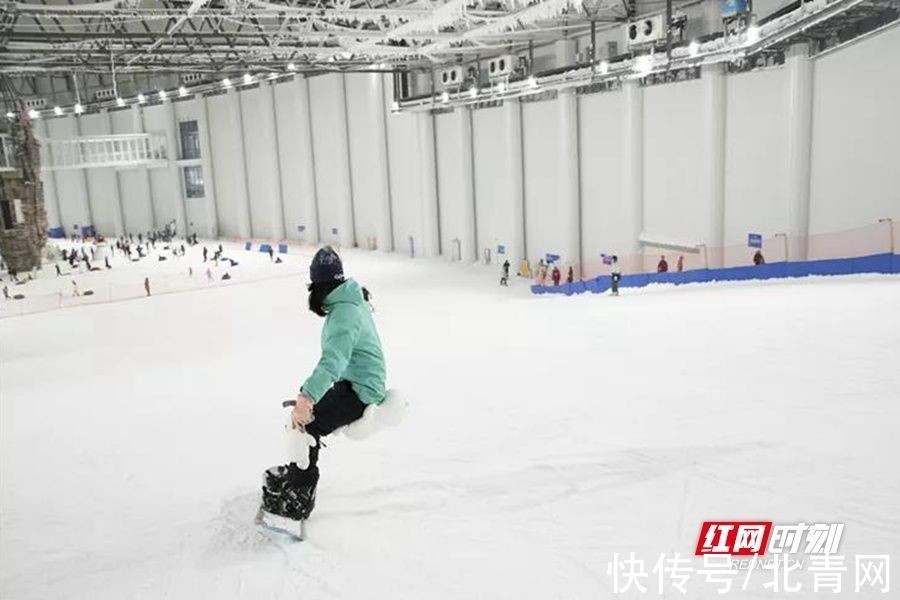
[0,0,627,75]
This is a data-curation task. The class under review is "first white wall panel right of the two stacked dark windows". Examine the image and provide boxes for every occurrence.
[207,92,251,237]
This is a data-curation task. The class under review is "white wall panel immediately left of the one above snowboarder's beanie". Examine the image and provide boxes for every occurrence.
[275,77,319,243]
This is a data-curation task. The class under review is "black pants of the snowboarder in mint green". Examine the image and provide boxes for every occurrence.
[287,381,366,486]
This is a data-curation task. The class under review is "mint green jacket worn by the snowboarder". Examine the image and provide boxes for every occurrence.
[302,279,385,404]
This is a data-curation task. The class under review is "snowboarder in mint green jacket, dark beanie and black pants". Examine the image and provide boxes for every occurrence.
[258,246,387,531]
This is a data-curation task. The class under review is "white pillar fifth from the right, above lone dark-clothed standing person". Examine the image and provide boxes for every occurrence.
[502,100,527,265]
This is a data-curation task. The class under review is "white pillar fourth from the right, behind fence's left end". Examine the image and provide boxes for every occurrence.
[556,90,581,273]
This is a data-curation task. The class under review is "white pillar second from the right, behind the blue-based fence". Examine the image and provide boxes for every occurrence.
[701,64,726,269]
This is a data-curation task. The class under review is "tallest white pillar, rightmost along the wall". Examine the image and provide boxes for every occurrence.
[785,44,813,261]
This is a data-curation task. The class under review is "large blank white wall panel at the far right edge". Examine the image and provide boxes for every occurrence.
[810,27,900,234]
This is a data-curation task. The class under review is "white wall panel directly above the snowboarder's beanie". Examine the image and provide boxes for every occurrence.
[309,74,354,246]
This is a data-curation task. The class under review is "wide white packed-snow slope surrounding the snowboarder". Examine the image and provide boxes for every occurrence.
[0,241,900,600]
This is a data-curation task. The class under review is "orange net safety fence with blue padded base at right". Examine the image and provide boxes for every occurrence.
[531,220,900,295]
